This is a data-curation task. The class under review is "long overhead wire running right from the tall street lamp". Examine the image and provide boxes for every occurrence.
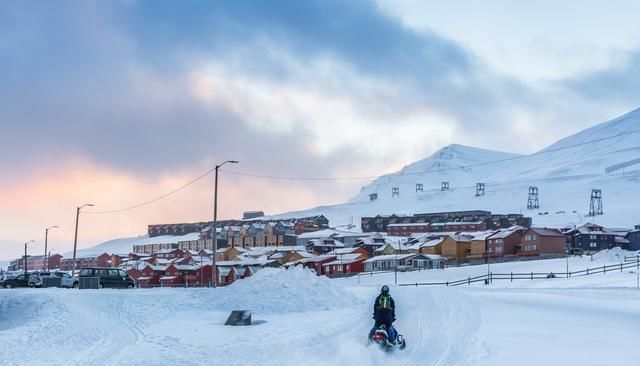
[222,129,640,181]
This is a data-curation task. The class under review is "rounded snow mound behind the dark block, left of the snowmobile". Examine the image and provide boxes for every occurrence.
[211,267,358,314]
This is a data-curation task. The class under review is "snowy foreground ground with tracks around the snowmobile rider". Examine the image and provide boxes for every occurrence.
[0,253,640,366]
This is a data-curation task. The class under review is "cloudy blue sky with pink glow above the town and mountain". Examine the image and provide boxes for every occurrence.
[0,0,640,259]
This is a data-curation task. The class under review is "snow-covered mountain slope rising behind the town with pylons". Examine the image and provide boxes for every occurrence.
[274,109,640,227]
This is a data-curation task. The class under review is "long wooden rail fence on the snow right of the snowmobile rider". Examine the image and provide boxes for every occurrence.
[398,255,640,286]
